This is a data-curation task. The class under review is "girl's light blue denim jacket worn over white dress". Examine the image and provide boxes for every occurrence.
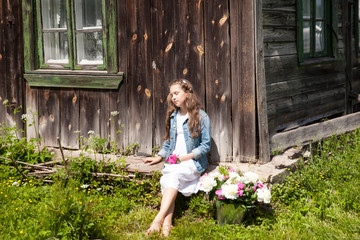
[158,110,211,172]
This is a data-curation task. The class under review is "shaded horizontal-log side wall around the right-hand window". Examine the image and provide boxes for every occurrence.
[263,0,345,134]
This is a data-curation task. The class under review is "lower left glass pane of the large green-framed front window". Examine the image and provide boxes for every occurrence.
[43,32,69,64]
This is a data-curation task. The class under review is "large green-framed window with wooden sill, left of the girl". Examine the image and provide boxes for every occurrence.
[22,0,123,89]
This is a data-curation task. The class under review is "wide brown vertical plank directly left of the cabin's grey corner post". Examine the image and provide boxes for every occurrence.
[230,0,257,162]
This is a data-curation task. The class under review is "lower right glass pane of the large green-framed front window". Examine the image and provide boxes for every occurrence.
[76,32,103,65]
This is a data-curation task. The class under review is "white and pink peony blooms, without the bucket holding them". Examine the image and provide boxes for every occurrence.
[200,167,271,207]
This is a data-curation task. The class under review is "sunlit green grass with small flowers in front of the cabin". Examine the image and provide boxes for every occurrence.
[0,130,360,240]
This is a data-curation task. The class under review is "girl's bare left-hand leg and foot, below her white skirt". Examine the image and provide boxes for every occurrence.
[146,188,178,234]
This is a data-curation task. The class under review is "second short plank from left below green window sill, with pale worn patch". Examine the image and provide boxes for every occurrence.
[38,88,60,146]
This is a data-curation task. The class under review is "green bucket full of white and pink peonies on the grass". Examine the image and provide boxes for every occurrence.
[200,167,271,224]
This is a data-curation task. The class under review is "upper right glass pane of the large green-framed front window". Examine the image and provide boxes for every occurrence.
[75,0,102,29]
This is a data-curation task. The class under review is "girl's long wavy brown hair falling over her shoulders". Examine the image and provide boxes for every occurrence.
[164,78,202,141]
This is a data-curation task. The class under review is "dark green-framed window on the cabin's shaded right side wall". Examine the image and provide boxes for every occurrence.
[298,0,332,62]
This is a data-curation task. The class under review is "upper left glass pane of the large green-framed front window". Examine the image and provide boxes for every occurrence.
[41,0,66,29]
